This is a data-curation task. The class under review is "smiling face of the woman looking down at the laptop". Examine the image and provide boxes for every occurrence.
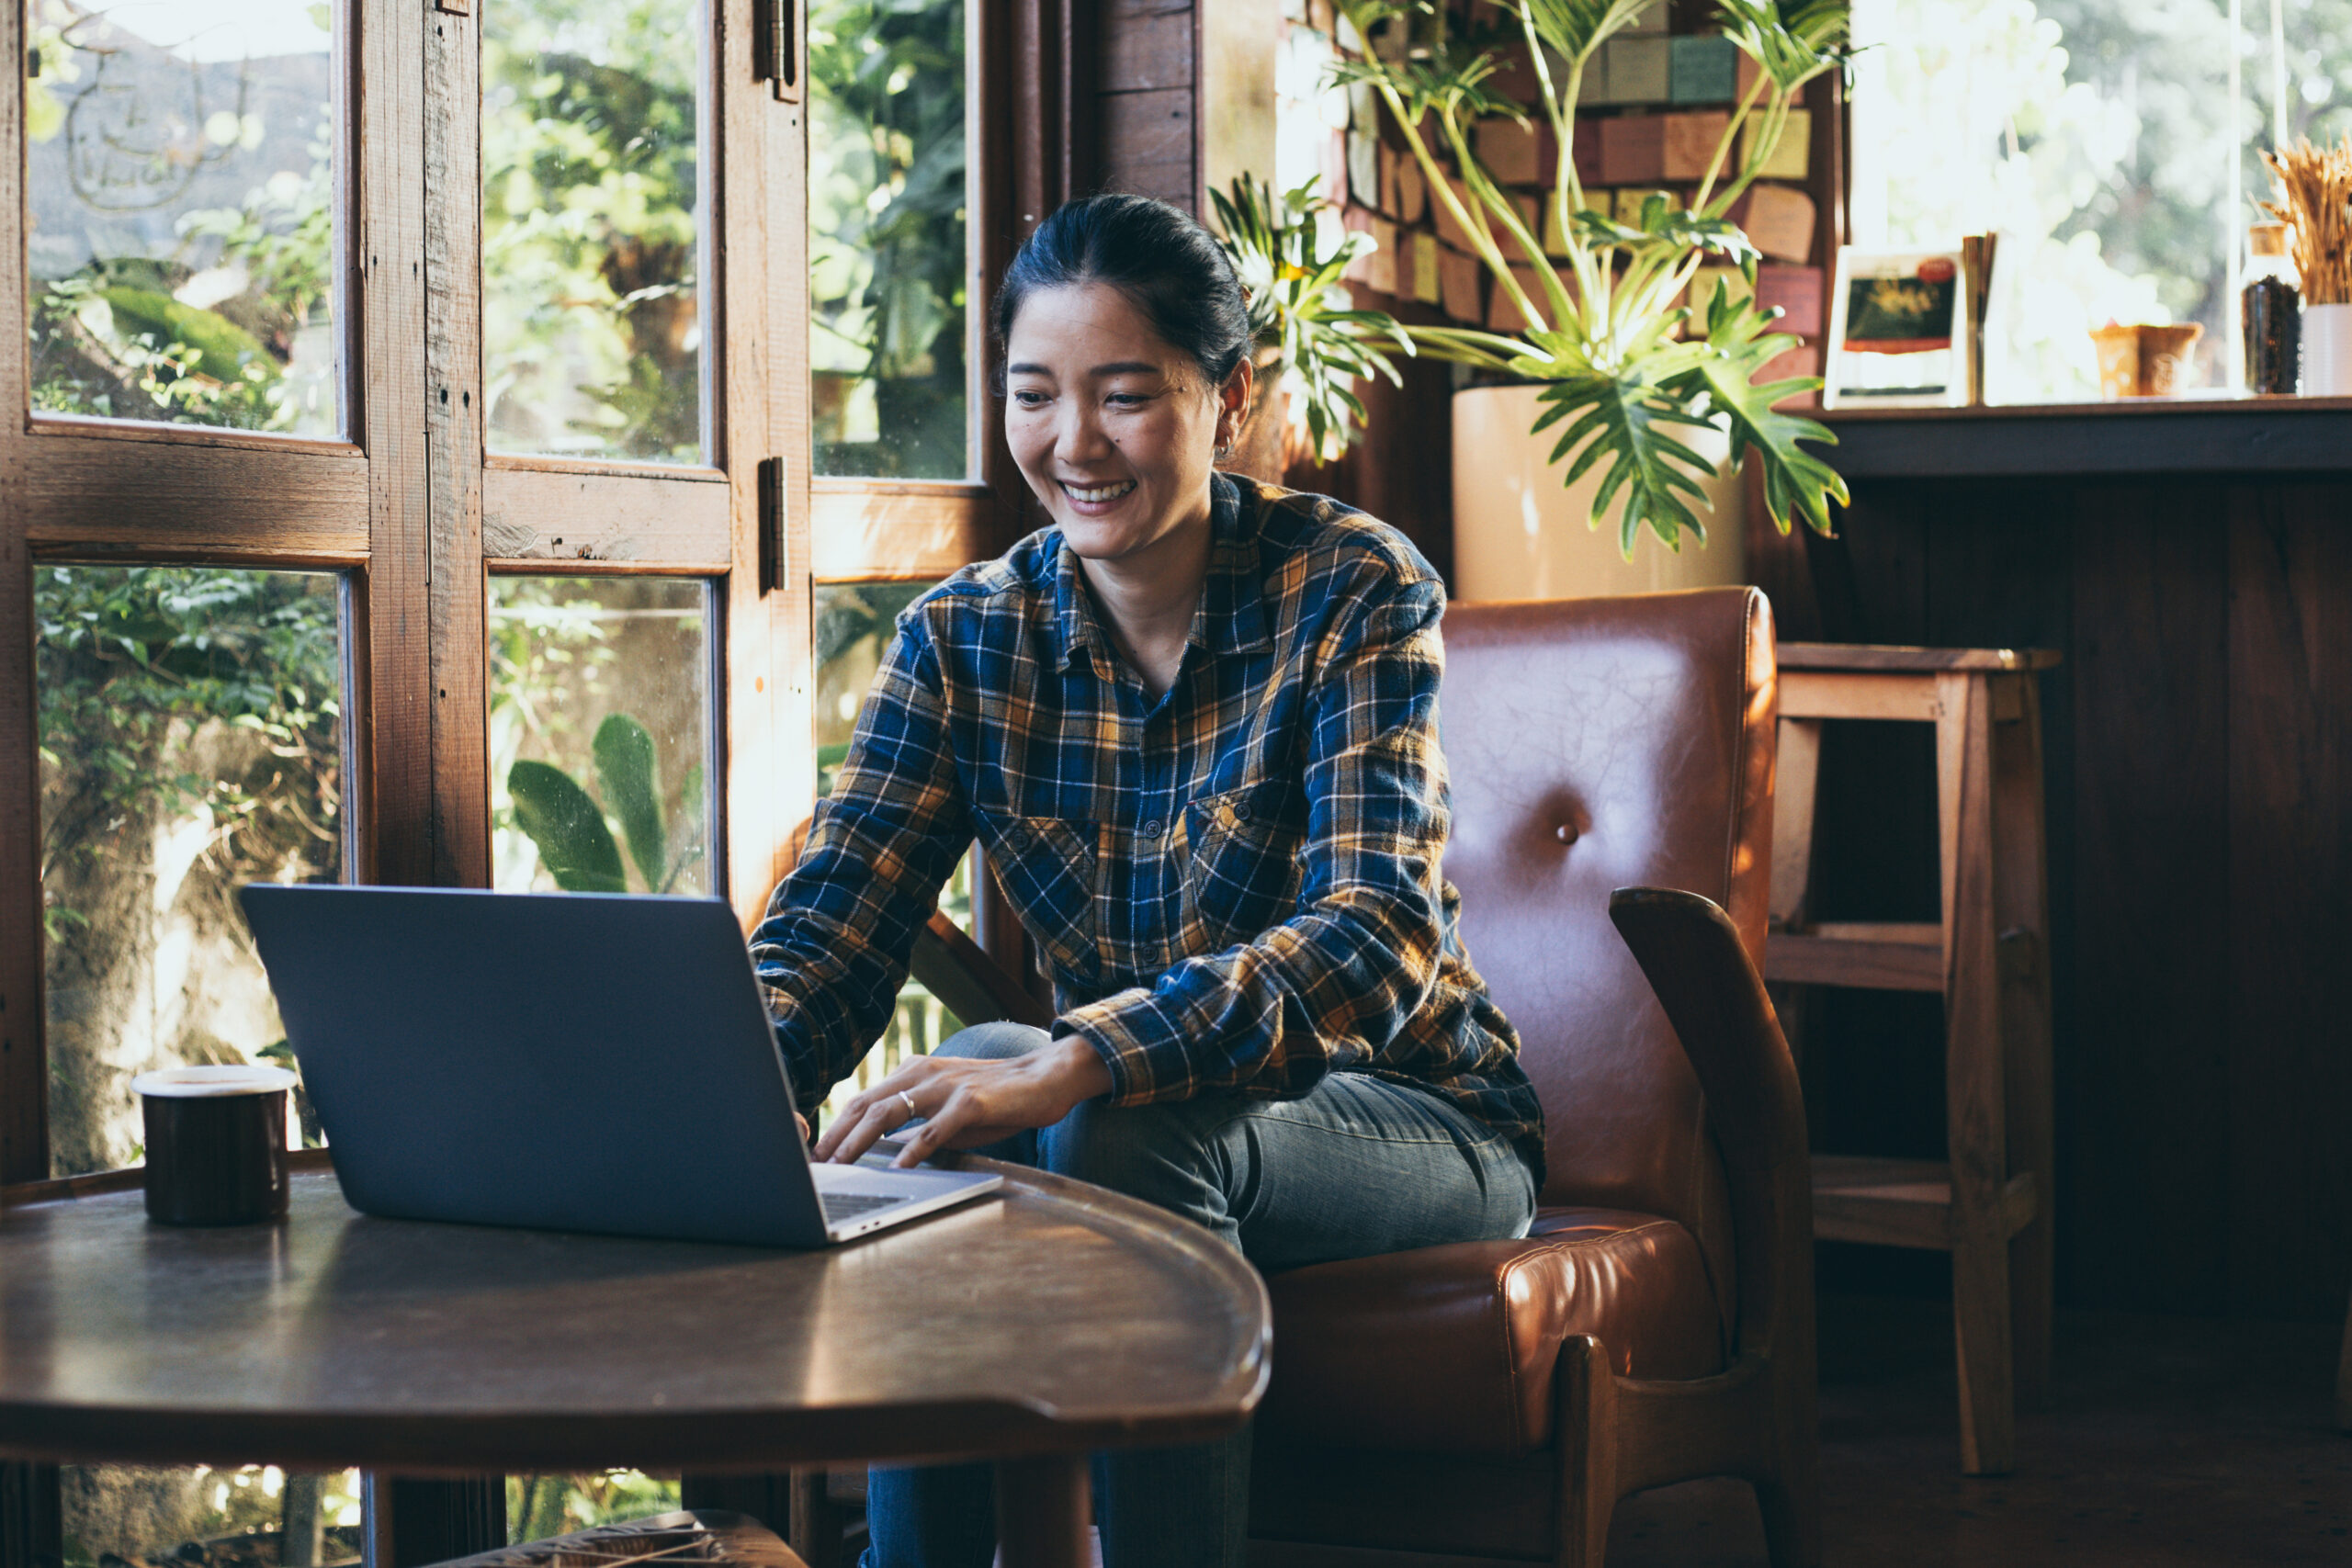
[1004,282,1249,569]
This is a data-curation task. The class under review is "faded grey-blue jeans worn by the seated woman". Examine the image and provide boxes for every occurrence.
[864,1022,1536,1568]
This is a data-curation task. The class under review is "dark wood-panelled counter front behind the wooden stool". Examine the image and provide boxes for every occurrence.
[1750,475,2352,1319]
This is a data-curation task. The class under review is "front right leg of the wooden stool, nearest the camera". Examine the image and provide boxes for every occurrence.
[1936,674,2016,1476]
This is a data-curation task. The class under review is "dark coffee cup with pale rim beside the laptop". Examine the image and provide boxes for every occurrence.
[131,1067,294,1224]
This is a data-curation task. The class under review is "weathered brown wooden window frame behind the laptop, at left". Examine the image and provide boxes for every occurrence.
[0,0,814,1201]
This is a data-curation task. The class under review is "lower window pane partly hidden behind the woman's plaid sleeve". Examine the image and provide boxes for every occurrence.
[816,583,971,1117]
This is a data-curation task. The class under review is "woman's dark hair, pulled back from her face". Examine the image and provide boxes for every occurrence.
[988,195,1249,390]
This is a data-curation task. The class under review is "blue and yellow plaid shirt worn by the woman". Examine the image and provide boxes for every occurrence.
[752,475,1543,1170]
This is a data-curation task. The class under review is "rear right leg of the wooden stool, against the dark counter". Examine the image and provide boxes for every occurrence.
[1992,674,2058,1411]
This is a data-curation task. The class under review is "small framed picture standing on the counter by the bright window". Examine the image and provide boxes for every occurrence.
[1820,247,1971,409]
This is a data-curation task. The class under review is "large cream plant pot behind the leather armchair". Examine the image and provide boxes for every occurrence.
[1453,386,1747,600]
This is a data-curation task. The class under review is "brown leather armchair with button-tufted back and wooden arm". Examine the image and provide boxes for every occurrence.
[1251,588,1818,1568]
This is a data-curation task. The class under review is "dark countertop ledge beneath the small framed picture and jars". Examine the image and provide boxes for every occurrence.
[1814,398,2352,479]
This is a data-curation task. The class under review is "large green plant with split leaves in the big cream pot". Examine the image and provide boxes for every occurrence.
[1336,0,1849,597]
